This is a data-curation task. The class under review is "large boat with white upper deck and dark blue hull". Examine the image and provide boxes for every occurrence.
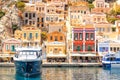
[13,47,42,77]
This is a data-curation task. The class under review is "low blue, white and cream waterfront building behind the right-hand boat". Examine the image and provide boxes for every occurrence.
[98,39,120,56]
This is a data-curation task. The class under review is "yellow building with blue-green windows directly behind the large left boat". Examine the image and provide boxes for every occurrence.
[14,26,41,46]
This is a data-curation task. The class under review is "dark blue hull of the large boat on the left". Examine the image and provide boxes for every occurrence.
[14,61,42,77]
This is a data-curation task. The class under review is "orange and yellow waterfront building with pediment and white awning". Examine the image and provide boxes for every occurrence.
[46,31,67,62]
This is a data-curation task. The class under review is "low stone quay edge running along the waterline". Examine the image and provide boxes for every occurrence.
[0,63,102,67]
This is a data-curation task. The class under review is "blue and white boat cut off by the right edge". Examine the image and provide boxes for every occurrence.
[102,52,120,69]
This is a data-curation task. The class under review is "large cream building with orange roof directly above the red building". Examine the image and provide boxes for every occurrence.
[69,1,90,26]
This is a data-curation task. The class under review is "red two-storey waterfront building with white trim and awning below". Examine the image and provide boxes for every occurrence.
[70,25,98,63]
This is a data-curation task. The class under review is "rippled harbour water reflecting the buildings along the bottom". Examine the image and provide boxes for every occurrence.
[0,67,120,80]
